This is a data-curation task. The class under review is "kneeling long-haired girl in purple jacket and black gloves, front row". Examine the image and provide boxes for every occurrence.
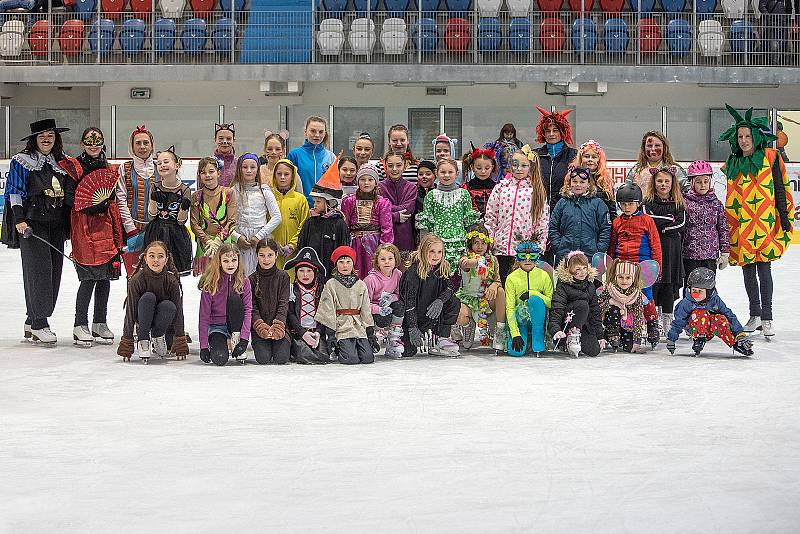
[197,243,253,365]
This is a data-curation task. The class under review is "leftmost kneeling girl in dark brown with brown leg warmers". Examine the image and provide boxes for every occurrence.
[117,241,189,363]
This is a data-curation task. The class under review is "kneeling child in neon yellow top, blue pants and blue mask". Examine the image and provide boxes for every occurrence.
[506,241,553,356]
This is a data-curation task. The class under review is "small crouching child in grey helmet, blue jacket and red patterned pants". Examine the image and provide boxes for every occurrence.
[667,267,753,356]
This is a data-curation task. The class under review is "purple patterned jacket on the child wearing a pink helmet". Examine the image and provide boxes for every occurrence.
[683,189,731,260]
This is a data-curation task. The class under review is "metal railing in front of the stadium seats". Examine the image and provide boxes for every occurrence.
[0,5,800,66]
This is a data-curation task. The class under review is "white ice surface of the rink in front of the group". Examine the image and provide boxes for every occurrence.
[0,247,800,534]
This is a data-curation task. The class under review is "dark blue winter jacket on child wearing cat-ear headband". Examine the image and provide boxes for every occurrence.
[549,193,611,264]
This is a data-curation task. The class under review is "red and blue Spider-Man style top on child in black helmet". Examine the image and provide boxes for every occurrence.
[608,210,661,267]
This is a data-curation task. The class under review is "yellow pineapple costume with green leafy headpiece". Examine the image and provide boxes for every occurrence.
[720,104,794,265]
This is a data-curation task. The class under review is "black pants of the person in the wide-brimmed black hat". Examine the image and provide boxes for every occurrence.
[19,221,64,330]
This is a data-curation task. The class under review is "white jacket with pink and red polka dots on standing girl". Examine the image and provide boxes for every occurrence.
[484,174,550,256]
